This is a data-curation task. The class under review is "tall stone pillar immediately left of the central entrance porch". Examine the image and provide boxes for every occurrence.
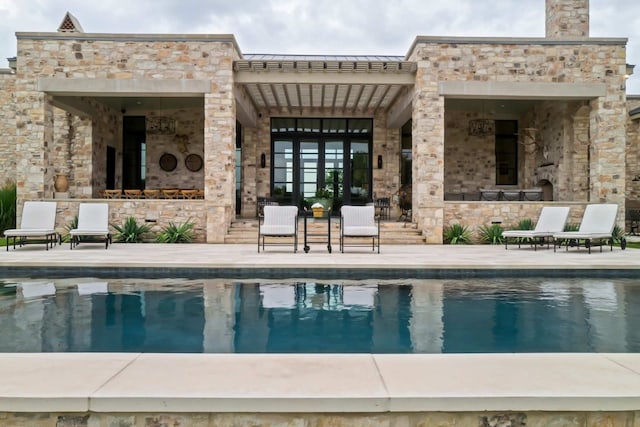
[204,78,236,243]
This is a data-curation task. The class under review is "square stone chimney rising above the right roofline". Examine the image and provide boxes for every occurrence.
[545,0,589,39]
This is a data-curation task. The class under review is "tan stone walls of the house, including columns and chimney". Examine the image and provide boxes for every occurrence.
[0,0,640,243]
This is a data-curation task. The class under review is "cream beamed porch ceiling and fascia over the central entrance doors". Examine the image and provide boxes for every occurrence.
[233,55,416,112]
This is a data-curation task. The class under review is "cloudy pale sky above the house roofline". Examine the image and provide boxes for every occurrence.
[0,0,640,95]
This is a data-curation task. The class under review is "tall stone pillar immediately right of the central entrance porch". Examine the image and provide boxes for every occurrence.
[411,74,444,244]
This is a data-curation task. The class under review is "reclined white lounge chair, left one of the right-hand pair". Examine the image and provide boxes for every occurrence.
[502,206,569,250]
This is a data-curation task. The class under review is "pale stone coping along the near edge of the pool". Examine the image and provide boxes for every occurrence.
[0,353,640,413]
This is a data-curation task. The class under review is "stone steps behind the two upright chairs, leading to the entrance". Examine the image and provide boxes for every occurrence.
[224,218,425,245]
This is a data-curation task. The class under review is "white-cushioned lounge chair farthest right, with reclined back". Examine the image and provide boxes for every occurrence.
[553,203,626,253]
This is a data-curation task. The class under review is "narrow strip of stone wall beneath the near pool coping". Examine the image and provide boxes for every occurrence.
[0,411,640,427]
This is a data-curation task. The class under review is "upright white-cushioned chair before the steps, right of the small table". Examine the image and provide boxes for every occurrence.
[340,205,380,253]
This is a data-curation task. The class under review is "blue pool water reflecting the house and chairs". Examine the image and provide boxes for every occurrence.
[0,278,640,353]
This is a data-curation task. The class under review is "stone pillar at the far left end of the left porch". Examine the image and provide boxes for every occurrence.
[15,91,54,200]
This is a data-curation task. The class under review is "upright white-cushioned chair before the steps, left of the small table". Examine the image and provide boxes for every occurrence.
[258,205,298,253]
